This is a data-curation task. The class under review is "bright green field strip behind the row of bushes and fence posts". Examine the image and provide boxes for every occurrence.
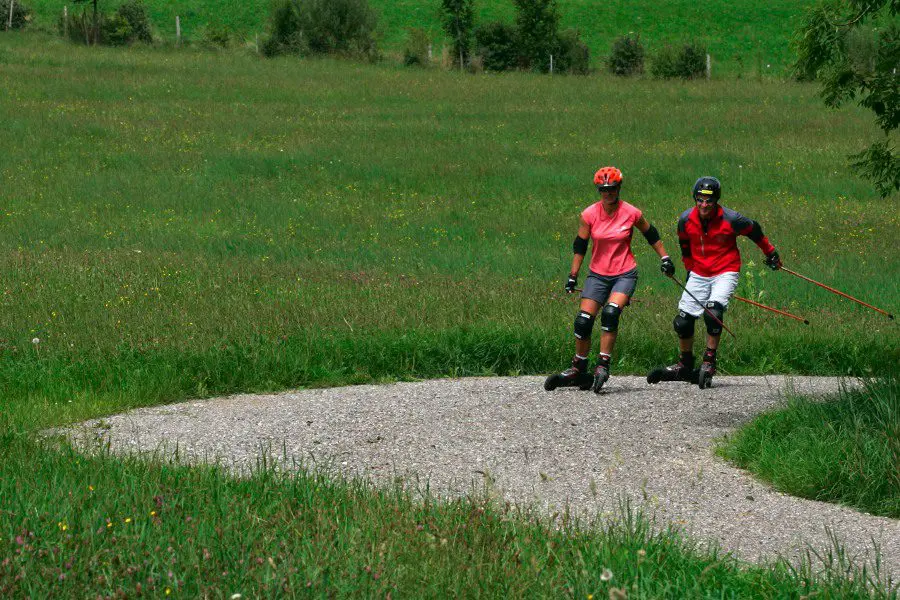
[25,0,809,76]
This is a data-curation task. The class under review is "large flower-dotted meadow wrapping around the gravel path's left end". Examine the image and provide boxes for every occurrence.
[0,34,900,598]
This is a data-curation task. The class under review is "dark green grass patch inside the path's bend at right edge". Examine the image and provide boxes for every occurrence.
[719,374,900,518]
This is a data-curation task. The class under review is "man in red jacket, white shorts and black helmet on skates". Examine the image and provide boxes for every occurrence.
[647,177,781,387]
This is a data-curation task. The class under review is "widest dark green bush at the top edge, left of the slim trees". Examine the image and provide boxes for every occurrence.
[262,0,378,59]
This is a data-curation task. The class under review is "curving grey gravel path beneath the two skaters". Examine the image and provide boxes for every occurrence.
[65,376,900,577]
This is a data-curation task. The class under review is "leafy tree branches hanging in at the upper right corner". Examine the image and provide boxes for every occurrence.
[796,0,900,197]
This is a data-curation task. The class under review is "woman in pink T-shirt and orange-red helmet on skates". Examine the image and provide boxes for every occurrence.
[544,167,675,393]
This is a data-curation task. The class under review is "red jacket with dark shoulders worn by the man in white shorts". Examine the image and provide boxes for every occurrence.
[678,206,775,277]
